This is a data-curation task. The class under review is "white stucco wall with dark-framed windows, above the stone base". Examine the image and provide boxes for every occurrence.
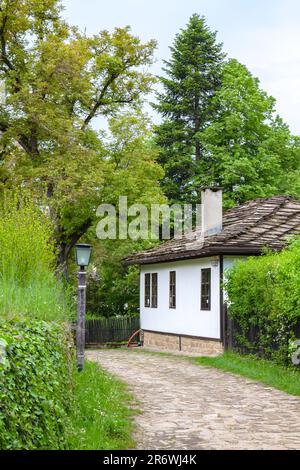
[140,258,220,339]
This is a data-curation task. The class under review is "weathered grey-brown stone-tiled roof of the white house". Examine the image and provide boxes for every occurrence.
[125,196,300,264]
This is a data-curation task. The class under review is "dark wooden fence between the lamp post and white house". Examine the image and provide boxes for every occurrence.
[85,317,140,346]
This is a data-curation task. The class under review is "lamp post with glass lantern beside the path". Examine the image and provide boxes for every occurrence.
[75,243,91,371]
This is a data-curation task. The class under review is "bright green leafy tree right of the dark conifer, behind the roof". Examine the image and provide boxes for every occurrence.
[196,60,300,206]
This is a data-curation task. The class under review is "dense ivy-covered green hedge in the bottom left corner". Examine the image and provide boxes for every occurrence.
[0,321,73,449]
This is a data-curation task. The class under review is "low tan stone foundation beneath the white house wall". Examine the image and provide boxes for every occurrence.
[144,331,224,356]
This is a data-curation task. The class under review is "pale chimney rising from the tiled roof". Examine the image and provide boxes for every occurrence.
[201,186,223,237]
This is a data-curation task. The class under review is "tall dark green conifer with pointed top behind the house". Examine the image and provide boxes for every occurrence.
[154,14,224,201]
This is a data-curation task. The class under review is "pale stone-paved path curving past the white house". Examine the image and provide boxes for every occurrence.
[87,350,300,450]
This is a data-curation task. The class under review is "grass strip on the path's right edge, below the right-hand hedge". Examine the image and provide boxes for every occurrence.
[192,352,300,396]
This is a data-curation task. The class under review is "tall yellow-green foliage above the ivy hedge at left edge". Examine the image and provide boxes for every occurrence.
[0,194,71,320]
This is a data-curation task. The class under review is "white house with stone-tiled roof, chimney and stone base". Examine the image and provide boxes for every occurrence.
[127,188,300,354]
